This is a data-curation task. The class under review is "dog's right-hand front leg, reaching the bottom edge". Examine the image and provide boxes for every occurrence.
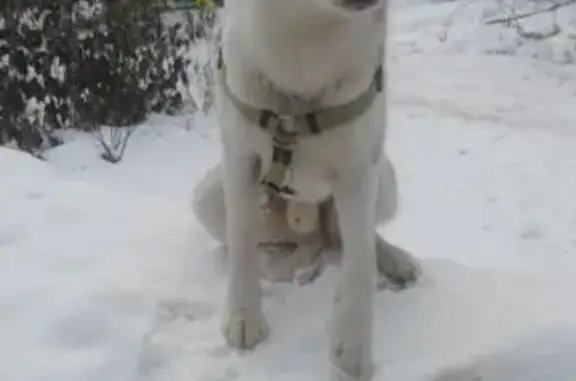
[331,167,377,381]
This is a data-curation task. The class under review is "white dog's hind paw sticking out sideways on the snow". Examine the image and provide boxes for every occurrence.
[376,237,422,289]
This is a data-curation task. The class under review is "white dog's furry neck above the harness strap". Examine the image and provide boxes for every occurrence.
[223,0,385,113]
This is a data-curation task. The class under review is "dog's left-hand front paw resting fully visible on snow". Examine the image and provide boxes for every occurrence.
[222,308,269,350]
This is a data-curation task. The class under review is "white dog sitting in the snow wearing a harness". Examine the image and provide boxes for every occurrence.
[194,0,419,380]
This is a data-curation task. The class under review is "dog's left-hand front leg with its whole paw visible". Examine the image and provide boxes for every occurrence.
[223,143,268,349]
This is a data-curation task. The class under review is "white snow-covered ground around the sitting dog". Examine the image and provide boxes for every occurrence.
[0,0,576,381]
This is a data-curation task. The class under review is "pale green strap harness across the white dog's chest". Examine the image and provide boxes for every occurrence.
[217,49,383,197]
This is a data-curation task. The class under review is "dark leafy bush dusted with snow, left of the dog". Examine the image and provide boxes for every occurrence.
[0,0,191,152]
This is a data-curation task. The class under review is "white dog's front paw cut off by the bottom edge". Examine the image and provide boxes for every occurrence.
[330,336,373,381]
